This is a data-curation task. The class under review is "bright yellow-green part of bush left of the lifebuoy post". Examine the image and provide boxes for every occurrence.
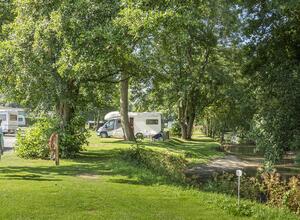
[16,119,54,159]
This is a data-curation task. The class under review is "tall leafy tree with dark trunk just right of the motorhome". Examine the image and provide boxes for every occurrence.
[117,1,239,139]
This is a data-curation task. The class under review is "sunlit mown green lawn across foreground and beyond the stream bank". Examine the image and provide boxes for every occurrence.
[0,133,295,220]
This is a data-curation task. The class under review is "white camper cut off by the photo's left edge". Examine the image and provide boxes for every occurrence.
[0,109,18,133]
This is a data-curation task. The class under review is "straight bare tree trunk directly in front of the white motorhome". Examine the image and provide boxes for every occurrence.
[120,74,135,141]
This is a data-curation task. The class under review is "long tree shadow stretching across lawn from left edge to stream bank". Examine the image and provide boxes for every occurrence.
[0,149,178,185]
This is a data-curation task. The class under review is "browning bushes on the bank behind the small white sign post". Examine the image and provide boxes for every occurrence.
[204,172,300,214]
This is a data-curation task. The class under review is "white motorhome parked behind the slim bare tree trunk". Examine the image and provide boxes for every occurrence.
[97,112,163,138]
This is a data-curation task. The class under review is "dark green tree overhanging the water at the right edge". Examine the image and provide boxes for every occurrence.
[242,0,300,162]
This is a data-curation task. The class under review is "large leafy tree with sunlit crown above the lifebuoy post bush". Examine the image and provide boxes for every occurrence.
[1,0,118,128]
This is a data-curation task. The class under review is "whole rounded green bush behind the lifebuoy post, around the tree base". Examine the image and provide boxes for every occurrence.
[16,117,89,159]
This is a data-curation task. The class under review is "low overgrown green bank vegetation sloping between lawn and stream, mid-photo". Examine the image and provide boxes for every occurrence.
[123,147,187,183]
